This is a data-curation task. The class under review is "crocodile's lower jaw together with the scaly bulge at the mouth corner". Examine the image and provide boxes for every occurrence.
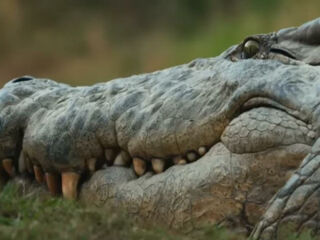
[79,102,315,232]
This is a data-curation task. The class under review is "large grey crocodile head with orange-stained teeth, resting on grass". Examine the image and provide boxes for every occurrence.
[0,18,320,239]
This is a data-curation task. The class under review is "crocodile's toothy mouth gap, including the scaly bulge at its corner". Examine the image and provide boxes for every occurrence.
[0,97,316,198]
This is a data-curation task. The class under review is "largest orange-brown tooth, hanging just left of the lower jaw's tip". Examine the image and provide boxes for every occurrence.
[61,172,80,200]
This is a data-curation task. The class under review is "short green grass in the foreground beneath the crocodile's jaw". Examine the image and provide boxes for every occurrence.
[0,184,313,240]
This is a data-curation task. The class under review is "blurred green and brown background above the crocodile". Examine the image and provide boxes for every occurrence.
[0,0,320,87]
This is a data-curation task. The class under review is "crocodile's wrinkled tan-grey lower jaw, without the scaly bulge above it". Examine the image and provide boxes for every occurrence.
[79,142,311,231]
